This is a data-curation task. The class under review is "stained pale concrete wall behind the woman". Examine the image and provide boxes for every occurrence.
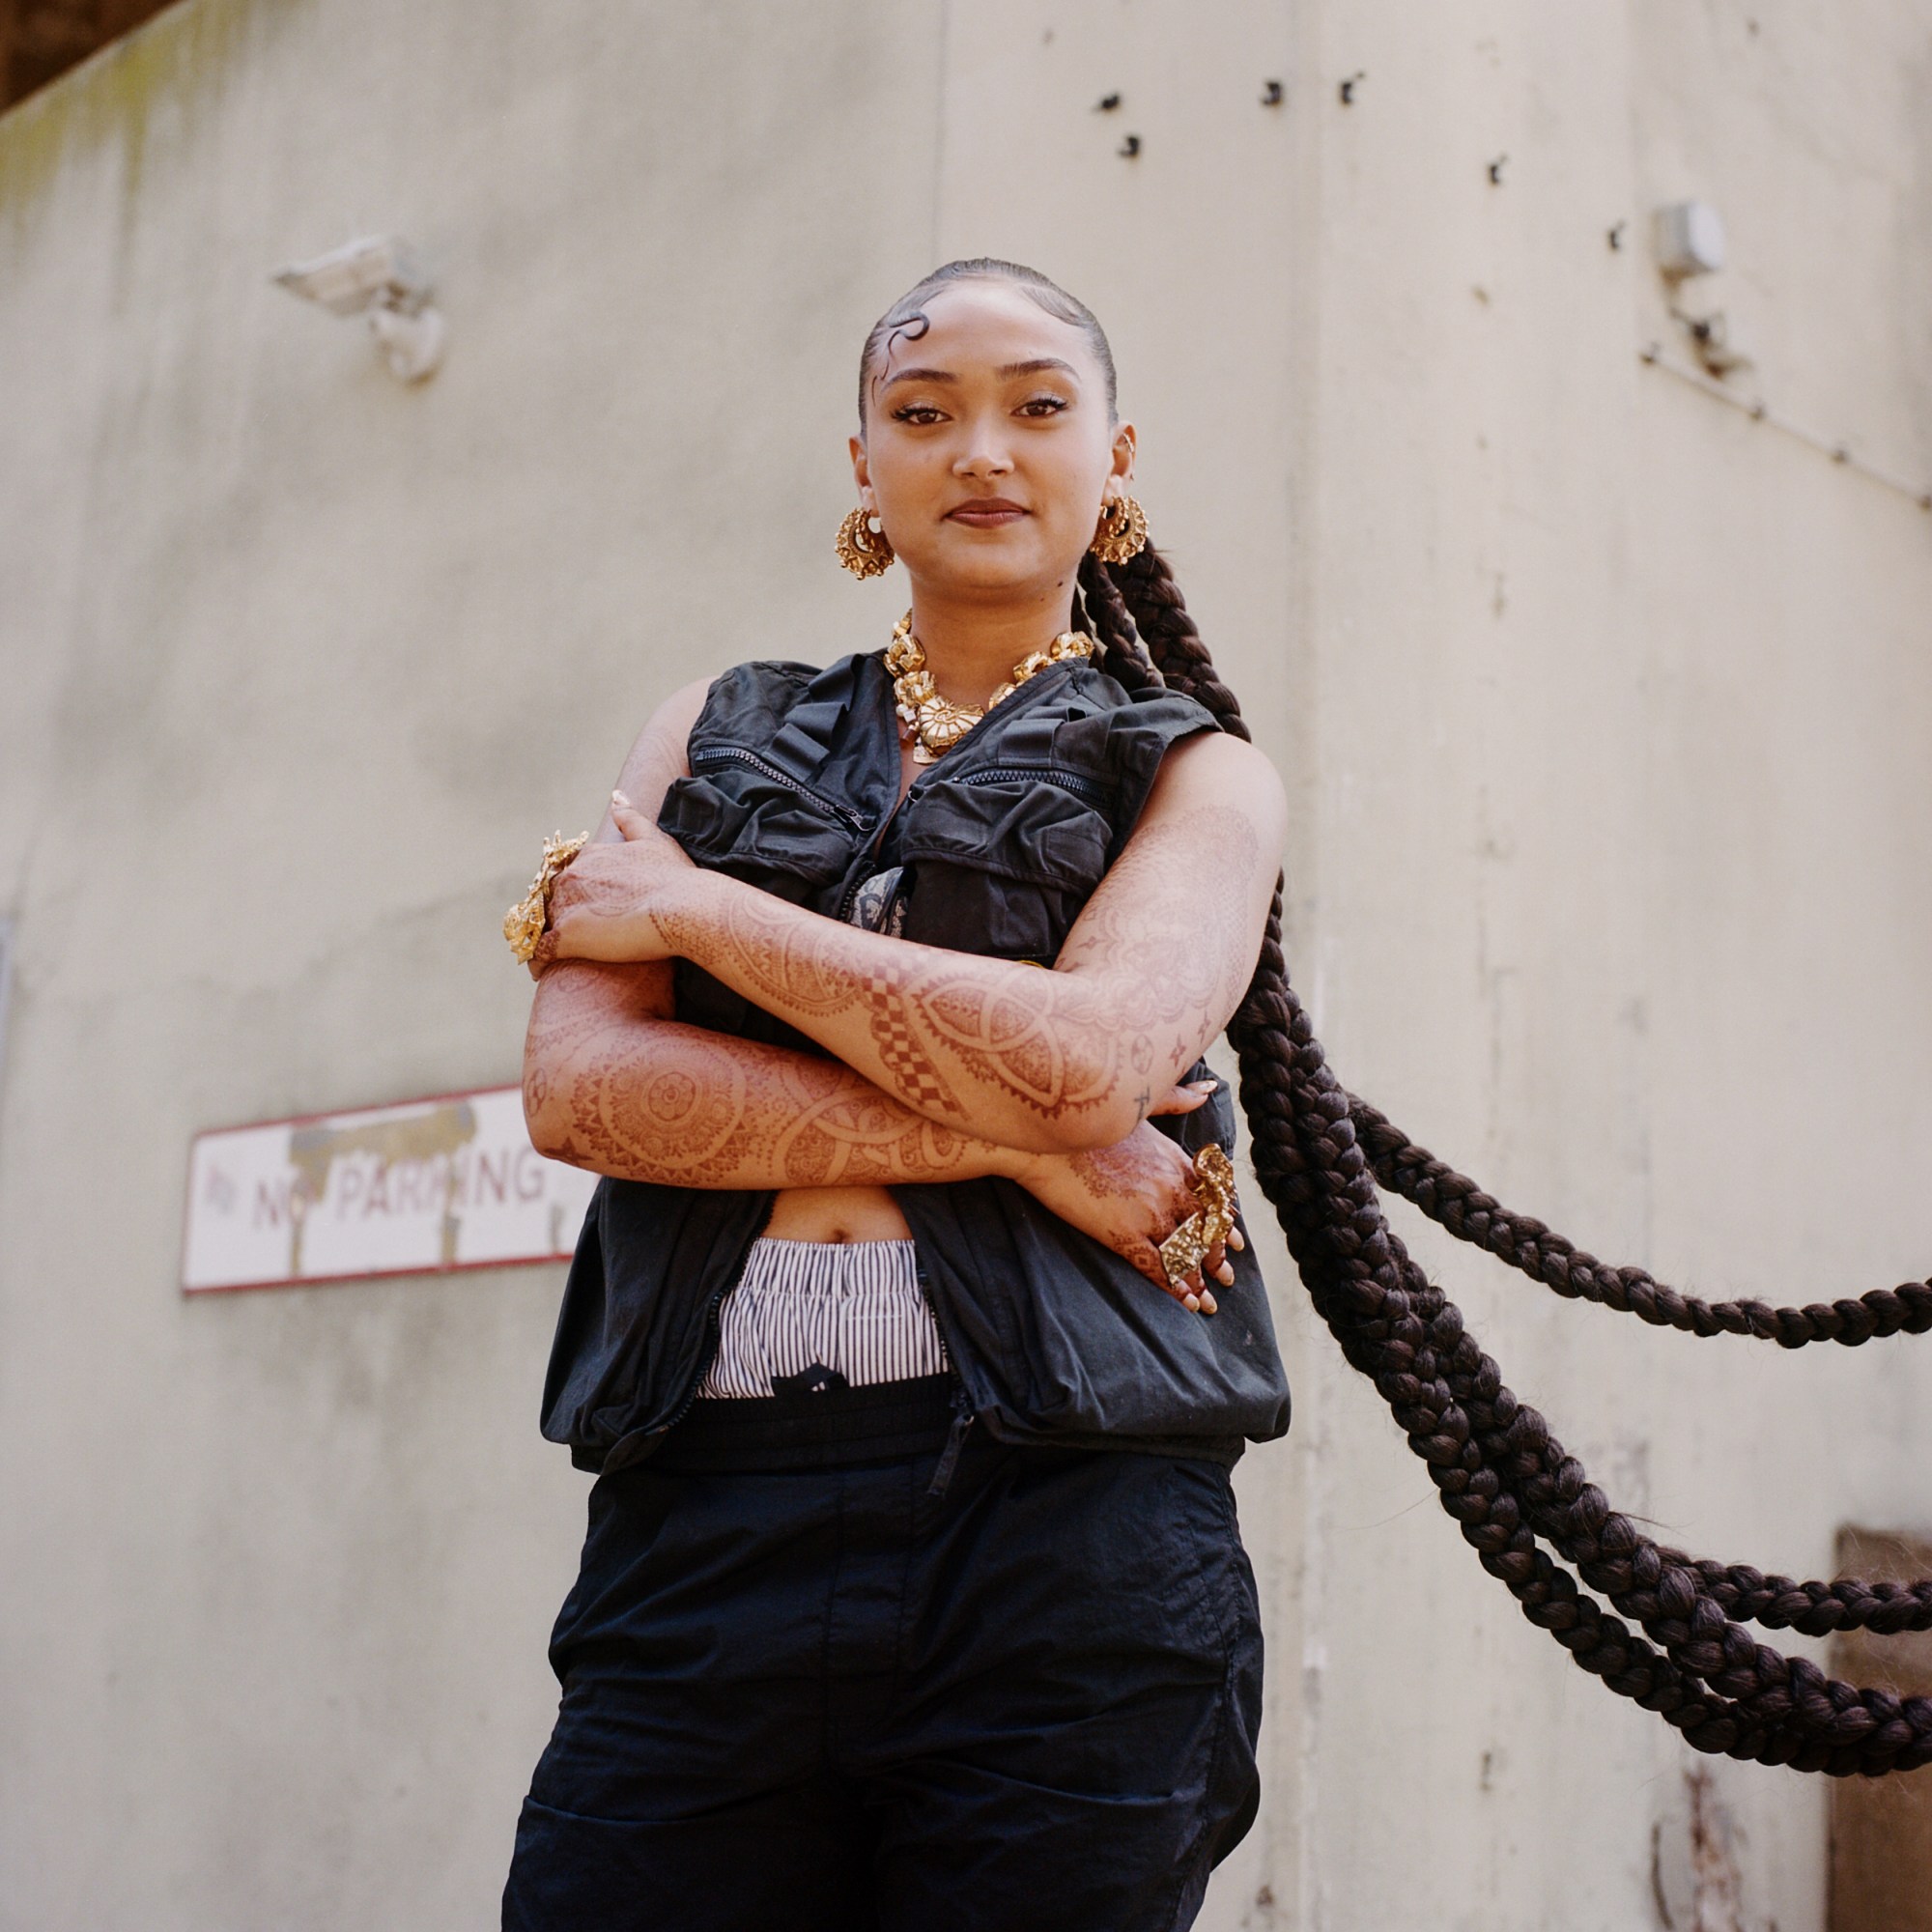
[0,0,1932,1932]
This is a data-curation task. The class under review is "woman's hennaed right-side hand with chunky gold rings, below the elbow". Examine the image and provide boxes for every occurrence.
[1012,1080,1246,1316]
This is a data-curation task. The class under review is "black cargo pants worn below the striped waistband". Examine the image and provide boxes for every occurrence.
[502,1430,1262,1932]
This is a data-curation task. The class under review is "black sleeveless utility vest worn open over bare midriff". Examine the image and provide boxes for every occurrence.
[543,651,1289,1468]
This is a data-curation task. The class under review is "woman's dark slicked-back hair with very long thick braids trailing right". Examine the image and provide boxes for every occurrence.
[860,259,1932,1776]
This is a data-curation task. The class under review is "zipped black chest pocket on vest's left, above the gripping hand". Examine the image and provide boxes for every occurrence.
[657,744,871,904]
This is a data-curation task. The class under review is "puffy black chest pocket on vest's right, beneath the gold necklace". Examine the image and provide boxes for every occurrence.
[898,765,1113,966]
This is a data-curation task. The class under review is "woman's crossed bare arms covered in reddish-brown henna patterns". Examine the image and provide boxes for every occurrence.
[524,686,1287,1285]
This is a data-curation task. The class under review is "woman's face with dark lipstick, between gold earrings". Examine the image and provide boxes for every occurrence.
[852,282,1134,595]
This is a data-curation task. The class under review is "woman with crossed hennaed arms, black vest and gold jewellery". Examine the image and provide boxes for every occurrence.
[504,261,1289,1932]
